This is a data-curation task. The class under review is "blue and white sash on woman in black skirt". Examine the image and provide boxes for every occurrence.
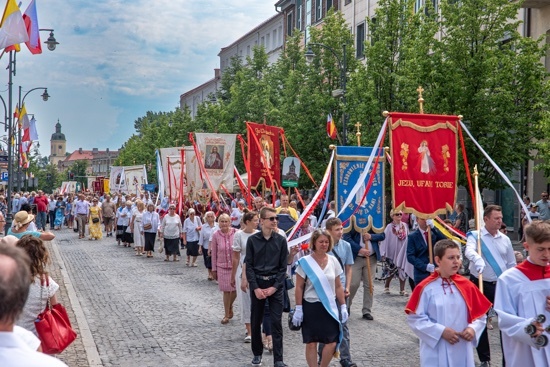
[298,255,343,351]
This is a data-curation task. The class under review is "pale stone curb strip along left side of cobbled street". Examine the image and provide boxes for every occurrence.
[50,240,103,367]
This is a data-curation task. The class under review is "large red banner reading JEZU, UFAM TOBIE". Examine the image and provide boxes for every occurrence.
[389,112,464,218]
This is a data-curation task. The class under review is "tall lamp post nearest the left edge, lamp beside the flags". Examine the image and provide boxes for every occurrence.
[5,28,59,232]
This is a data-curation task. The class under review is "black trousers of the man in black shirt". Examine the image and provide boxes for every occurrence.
[250,279,283,362]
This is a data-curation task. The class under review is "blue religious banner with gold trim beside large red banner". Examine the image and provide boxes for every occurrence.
[334,146,386,233]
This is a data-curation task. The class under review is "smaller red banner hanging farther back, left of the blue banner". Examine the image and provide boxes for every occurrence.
[246,122,283,190]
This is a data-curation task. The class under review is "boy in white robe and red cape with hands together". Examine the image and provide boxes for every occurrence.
[405,240,491,366]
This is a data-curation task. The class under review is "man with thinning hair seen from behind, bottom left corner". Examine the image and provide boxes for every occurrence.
[0,246,67,367]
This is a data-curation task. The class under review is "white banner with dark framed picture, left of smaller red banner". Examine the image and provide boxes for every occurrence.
[195,133,237,192]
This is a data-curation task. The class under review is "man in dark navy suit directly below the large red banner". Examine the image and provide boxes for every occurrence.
[407,217,445,284]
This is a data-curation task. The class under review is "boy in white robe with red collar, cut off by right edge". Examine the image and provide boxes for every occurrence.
[495,221,550,366]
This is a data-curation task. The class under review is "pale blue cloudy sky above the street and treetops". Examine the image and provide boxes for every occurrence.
[11,0,276,160]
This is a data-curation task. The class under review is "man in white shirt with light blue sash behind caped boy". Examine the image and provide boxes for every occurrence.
[464,205,516,367]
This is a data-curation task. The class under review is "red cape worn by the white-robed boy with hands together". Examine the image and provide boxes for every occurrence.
[405,270,492,323]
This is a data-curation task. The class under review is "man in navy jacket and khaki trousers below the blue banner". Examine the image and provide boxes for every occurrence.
[344,226,386,320]
